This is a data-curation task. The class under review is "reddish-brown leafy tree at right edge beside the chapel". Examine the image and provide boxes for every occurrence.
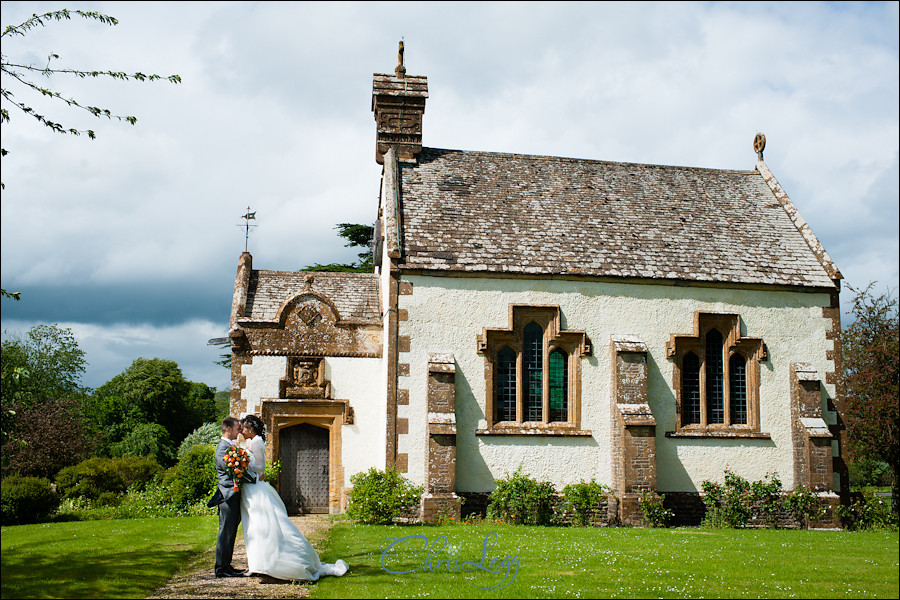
[841,283,900,511]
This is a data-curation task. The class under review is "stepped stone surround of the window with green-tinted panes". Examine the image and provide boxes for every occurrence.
[476,304,591,436]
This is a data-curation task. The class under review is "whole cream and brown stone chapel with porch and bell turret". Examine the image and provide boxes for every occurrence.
[228,49,849,523]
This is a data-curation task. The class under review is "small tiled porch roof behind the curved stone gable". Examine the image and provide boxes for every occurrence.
[242,271,381,324]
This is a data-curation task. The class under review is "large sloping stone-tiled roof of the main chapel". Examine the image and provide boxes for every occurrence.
[400,148,834,288]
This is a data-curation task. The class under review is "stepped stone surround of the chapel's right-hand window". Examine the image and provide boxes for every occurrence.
[666,311,771,439]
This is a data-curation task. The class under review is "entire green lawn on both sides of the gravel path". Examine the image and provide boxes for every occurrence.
[2,517,900,598]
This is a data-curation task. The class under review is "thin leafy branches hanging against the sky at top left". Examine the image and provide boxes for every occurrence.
[0,9,181,155]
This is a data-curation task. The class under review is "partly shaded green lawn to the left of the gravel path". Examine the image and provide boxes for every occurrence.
[0,516,218,598]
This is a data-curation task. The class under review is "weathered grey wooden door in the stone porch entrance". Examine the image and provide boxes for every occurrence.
[278,423,330,514]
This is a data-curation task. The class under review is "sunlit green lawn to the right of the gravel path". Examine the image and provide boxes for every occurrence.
[311,521,900,598]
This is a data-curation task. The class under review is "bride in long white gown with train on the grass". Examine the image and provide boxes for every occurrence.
[241,415,348,581]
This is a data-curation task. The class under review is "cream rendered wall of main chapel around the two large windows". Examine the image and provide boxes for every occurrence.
[398,276,834,492]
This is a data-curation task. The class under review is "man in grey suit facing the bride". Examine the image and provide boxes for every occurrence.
[208,417,256,577]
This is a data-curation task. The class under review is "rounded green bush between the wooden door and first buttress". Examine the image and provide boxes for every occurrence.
[347,467,423,524]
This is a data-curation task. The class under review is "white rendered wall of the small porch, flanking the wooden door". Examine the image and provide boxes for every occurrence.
[239,356,387,486]
